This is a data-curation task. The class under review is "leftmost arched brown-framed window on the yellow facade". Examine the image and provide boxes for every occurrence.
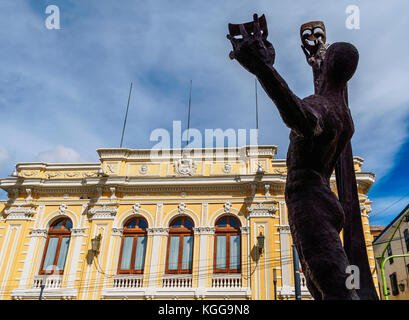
[40,218,72,274]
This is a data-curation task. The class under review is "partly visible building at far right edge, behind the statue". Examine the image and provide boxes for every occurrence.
[373,204,409,300]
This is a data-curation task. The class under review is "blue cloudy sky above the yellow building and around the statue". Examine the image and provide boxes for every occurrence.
[0,0,409,225]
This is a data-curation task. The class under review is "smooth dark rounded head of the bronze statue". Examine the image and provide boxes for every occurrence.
[323,42,359,86]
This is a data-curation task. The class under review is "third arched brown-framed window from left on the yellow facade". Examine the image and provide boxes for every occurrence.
[166,217,193,273]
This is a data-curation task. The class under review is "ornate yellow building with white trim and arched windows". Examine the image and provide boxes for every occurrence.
[0,146,377,299]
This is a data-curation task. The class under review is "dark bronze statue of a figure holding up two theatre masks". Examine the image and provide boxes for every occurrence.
[227,15,377,300]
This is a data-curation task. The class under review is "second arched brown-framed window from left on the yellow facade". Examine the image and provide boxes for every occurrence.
[118,217,148,274]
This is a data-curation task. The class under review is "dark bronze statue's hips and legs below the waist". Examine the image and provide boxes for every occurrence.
[286,185,358,300]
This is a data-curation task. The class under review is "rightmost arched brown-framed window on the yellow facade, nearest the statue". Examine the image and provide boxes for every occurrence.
[214,216,241,273]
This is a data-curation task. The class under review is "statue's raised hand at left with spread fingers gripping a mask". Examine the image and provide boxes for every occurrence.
[227,15,275,74]
